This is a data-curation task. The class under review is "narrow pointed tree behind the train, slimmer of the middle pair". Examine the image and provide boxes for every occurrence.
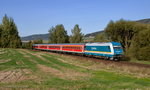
[69,24,83,43]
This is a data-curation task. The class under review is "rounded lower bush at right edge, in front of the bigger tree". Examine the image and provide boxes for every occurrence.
[130,27,150,60]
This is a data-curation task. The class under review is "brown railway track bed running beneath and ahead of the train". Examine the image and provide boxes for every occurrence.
[33,50,150,68]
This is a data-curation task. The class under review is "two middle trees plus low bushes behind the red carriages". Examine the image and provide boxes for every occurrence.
[22,24,84,49]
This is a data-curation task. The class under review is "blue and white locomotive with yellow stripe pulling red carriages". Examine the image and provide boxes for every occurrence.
[84,42,123,60]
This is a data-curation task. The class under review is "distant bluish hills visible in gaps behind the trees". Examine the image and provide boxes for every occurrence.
[21,19,150,41]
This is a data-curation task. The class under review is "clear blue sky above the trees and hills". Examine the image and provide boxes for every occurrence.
[0,0,150,36]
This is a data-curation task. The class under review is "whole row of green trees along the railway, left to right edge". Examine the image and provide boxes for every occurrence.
[0,15,150,60]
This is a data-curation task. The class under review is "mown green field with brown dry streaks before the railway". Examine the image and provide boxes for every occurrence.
[0,48,150,90]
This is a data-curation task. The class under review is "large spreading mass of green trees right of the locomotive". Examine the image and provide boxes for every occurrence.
[105,19,150,60]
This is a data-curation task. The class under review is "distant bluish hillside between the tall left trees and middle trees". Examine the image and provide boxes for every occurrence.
[21,33,49,41]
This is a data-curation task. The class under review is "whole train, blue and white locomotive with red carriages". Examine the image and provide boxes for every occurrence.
[32,42,123,60]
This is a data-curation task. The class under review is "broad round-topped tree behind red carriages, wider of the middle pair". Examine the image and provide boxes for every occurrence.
[49,24,69,43]
